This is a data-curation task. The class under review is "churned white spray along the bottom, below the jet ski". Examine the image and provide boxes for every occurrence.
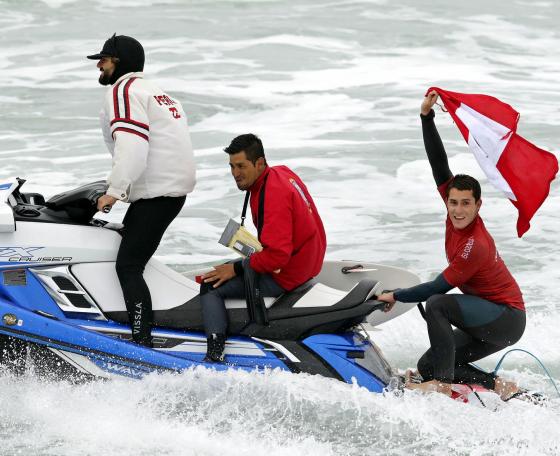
[0,369,559,455]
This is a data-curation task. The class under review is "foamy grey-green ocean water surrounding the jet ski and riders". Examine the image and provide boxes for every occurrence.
[0,0,560,455]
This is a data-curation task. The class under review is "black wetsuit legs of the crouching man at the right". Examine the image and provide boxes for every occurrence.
[418,294,525,389]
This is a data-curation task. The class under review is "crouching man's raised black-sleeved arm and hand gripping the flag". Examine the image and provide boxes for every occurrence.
[420,90,453,187]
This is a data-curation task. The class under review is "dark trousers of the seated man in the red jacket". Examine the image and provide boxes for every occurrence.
[200,274,285,336]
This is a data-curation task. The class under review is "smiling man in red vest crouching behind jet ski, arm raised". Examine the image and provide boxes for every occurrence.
[378,91,525,399]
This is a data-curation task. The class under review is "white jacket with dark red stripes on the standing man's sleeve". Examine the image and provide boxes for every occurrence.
[101,73,195,202]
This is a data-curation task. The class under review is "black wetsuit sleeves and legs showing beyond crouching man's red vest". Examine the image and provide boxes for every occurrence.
[394,111,525,389]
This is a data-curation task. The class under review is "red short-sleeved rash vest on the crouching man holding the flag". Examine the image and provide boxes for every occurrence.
[438,180,525,310]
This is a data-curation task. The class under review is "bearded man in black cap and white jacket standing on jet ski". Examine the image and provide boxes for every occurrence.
[87,34,195,347]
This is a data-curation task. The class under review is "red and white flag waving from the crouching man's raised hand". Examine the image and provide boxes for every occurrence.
[427,87,558,237]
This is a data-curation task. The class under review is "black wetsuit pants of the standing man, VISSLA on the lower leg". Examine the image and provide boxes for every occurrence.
[116,196,186,345]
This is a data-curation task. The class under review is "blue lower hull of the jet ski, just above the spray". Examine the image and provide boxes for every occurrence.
[0,302,391,392]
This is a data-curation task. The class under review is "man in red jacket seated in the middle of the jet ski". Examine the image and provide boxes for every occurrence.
[200,134,327,362]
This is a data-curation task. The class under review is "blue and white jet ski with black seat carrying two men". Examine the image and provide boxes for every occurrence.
[0,179,419,392]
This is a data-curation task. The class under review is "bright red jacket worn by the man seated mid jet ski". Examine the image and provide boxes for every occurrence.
[249,166,327,290]
